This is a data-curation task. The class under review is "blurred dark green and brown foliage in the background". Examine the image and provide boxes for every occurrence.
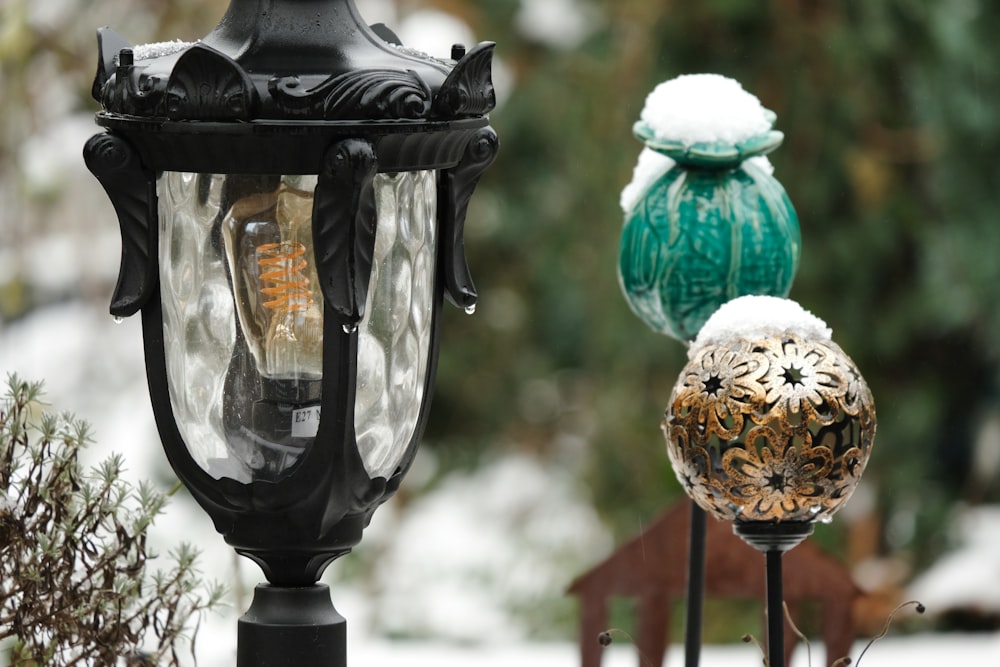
[0,0,1000,580]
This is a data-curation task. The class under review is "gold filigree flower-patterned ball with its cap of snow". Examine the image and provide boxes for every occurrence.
[663,296,875,523]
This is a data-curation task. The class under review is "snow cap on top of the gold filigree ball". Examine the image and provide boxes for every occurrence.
[688,295,833,359]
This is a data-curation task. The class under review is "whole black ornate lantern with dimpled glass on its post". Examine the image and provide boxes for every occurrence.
[84,0,498,667]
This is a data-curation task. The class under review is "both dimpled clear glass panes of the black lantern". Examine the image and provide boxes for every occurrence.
[158,172,436,482]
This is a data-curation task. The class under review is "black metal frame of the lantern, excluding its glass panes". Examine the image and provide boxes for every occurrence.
[84,0,499,665]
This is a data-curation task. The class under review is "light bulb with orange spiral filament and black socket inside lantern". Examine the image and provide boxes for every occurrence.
[222,180,323,479]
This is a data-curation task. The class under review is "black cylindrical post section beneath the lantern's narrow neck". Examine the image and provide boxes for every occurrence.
[236,584,347,667]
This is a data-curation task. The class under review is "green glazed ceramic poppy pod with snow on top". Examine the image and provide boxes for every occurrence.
[618,74,801,340]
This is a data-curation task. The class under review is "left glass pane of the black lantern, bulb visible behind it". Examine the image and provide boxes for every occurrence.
[158,172,323,482]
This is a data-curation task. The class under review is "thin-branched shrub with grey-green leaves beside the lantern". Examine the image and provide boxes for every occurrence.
[0,376,223,667]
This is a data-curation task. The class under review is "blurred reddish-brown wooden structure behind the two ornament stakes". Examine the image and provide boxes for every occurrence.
[568,501,864,667]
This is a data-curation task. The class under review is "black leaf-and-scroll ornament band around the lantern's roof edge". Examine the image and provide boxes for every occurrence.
[92,28,496,122]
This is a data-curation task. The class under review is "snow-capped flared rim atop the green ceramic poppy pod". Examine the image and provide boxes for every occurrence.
[633,74,784,166]
